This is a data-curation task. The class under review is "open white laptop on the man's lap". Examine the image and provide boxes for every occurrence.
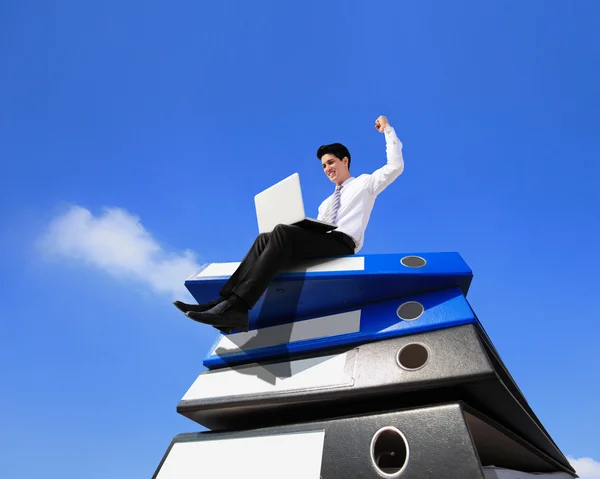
[254,173,337,233]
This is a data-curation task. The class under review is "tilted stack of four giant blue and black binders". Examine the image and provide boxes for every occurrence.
[153,253,577,479]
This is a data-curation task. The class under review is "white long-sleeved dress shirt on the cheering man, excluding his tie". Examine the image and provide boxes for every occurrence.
[317,126,404,254]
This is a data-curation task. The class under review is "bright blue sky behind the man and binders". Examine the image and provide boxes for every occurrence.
[0,0,600,479]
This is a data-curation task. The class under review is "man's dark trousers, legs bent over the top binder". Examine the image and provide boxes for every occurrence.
[220,225,354,309]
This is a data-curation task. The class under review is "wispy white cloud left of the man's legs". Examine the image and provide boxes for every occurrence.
[40,206,199,297]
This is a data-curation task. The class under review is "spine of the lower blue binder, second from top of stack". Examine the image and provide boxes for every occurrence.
[203,288,476,369]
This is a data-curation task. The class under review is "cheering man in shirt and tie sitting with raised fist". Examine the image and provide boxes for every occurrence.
[173,116,404,333]
